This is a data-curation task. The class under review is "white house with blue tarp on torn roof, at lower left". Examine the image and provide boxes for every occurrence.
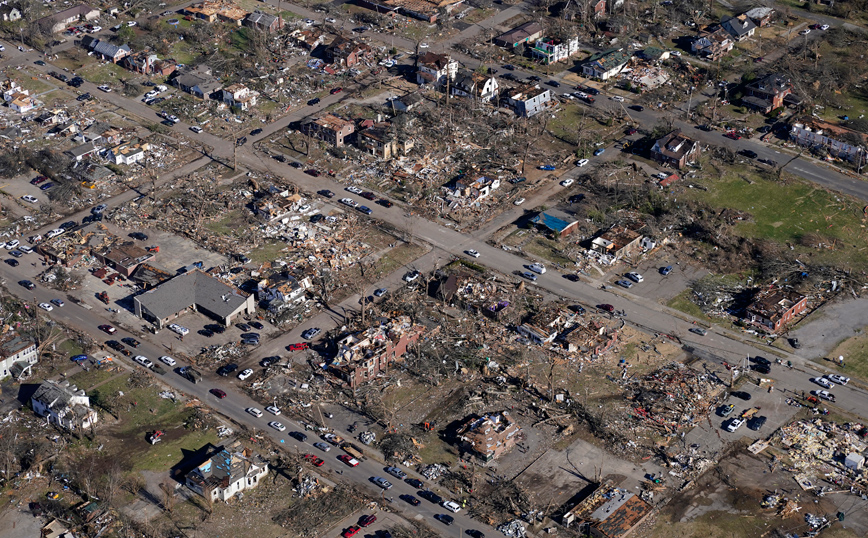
[184,441,268,502]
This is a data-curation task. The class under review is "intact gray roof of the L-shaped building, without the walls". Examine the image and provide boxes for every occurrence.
[136,270,249,319]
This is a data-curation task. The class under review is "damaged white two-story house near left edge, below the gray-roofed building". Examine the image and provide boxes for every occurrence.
[30,380,99,431]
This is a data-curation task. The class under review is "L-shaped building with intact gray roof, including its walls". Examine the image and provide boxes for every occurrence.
[133,269,256,329]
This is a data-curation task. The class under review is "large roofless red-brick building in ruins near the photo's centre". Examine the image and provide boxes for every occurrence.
[329,316,425,388]
